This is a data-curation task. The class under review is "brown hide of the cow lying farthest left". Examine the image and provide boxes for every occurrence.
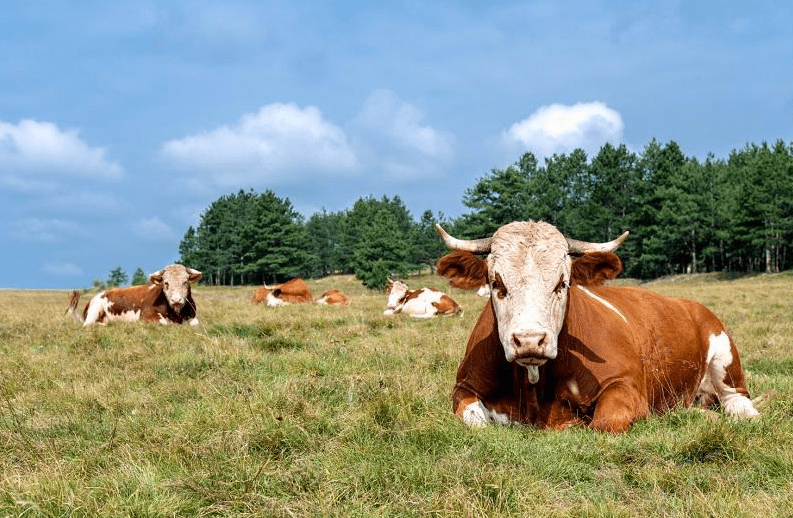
[70,284,196,324]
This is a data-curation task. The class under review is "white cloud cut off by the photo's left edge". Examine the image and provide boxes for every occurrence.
[0,120,124,184]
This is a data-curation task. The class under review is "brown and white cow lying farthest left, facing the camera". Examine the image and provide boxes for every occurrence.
[67,264,201,326]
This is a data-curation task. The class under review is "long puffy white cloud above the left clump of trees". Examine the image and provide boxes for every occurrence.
[162,103,358,186]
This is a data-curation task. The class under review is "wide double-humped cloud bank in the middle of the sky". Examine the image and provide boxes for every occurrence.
[161,90,454,187]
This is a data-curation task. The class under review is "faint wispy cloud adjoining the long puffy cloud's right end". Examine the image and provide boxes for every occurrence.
[351,90,454,183]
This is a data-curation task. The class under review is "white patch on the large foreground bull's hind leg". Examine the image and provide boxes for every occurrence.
[699,331,758,417]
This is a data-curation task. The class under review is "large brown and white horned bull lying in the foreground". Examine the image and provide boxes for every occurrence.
[437,221,757,432]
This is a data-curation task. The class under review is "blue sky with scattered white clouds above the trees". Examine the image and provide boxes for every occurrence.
[0,0,793,288]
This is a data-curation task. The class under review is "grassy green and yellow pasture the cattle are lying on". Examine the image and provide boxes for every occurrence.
[0,273,793,518]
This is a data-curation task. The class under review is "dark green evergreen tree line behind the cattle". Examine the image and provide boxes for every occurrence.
[179,140,793,288]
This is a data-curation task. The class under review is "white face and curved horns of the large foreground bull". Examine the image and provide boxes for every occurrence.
[436,221,628,383]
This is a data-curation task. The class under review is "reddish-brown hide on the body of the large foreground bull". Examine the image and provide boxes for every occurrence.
[452,253,748,432]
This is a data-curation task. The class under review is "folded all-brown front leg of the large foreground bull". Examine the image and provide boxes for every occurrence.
[590,382,650,433]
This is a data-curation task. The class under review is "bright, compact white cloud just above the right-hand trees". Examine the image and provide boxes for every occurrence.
[501,102,625,158]
